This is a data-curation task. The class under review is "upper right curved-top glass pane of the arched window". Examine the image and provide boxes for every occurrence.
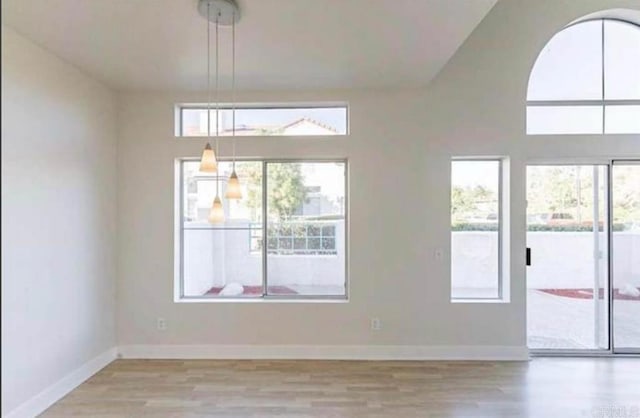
[604,20,640,100]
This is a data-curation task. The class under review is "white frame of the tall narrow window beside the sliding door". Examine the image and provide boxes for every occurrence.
[449,157,510,303]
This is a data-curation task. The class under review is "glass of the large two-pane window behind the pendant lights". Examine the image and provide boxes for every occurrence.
[178,160,347,299]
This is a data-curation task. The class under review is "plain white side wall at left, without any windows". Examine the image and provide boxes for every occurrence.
[2,25,116,415]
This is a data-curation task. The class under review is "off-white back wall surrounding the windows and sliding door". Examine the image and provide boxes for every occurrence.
[118,0,640,347]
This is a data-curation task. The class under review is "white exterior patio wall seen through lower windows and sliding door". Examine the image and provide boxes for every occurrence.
[184,225,640,295]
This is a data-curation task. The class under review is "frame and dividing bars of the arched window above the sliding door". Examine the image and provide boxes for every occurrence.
[525,17,640,136]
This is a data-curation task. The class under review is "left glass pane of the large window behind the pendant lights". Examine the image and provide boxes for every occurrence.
[182,161,262,297]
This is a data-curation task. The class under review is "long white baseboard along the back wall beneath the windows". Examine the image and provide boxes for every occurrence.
[119,345,529,361]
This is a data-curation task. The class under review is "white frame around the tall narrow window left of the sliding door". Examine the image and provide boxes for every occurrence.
[449,157,509,303]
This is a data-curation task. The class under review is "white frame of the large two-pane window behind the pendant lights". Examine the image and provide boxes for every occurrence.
[174,157,349,303]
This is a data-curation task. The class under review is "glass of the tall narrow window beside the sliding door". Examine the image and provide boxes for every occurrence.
[451,161,500,299]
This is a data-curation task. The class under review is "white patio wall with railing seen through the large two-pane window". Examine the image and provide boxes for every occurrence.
[183,220,345,296]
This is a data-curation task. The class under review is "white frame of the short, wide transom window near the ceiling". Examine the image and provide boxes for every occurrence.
[175,102,350,139]
